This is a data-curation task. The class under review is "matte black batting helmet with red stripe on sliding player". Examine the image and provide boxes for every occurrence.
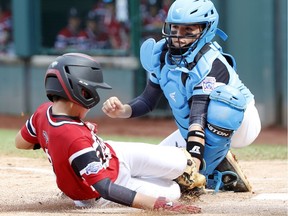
[45,53,111,109]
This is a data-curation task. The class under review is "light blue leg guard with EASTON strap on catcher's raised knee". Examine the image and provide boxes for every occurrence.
[203,85,246,175]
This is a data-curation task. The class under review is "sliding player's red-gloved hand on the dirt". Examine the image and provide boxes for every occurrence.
[154,197,201,214]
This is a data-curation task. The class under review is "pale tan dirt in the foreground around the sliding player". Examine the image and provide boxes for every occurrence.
[0,157,288,216]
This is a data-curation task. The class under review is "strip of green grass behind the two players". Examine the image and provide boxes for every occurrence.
[0,129,288,160]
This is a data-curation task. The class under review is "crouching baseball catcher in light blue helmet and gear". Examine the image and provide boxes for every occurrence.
[102,0,261,192]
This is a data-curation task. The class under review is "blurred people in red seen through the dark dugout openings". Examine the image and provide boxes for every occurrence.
[0,0,173,55]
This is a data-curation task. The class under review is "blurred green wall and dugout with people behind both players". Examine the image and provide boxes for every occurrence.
[0,0,288,126]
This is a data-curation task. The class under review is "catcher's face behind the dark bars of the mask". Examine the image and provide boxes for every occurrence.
[171,24,201,47]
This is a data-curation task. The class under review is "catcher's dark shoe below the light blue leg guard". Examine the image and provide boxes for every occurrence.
[207,151,252,192]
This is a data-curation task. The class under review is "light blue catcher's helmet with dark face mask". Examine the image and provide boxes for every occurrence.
[162,0,219,66]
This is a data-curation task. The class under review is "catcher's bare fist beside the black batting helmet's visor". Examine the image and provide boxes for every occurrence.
[102,97,132,118]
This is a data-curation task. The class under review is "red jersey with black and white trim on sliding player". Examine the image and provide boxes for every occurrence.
[21,103,119,200]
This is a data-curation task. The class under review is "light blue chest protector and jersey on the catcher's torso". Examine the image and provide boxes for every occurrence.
[141,39,254,139]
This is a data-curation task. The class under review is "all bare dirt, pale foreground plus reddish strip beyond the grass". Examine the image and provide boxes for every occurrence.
[0,116,288,216]
